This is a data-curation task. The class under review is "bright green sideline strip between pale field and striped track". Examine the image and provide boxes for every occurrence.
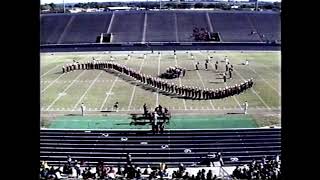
[48,115,257,129]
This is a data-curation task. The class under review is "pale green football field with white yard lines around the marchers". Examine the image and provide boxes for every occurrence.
[41,51,281,128]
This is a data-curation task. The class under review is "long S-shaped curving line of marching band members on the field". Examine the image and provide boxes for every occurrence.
[62,60,253,100]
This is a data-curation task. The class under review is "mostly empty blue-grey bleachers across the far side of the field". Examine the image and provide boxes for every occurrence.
[40,11,281,44]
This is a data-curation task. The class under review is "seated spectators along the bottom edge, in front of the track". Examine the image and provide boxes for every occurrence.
[39,153,282,180]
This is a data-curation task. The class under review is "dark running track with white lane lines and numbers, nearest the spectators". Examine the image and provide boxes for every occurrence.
[40,128,281,167]
